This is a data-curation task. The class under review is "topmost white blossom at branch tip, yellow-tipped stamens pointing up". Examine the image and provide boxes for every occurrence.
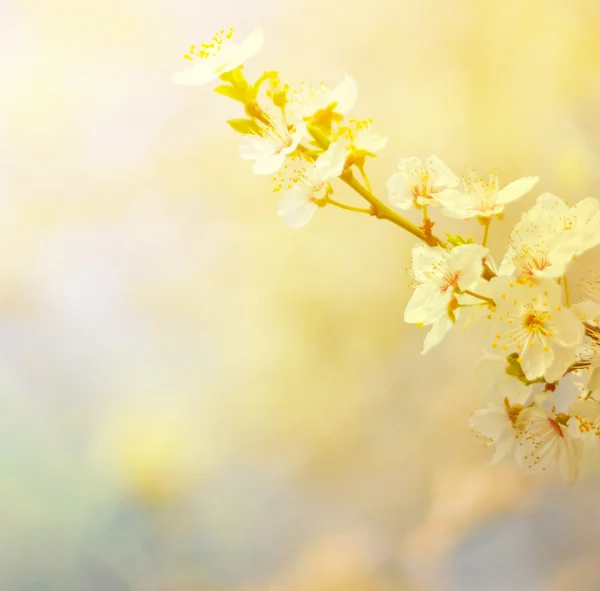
[173,29,264,86]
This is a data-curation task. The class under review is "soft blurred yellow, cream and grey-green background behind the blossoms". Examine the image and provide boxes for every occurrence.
[0,0,600,591]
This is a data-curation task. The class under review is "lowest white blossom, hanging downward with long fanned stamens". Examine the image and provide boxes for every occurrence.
[515,395,583,483]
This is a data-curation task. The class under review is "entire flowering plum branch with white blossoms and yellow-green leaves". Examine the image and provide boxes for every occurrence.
[173,30,600,482]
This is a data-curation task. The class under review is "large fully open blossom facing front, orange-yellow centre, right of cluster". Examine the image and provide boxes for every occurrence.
[488,277,584,382]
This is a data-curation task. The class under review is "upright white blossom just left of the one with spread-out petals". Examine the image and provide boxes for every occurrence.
[386,155,458,209]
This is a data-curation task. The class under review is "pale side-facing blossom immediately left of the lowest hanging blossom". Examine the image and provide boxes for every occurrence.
[469,355,532,463]
